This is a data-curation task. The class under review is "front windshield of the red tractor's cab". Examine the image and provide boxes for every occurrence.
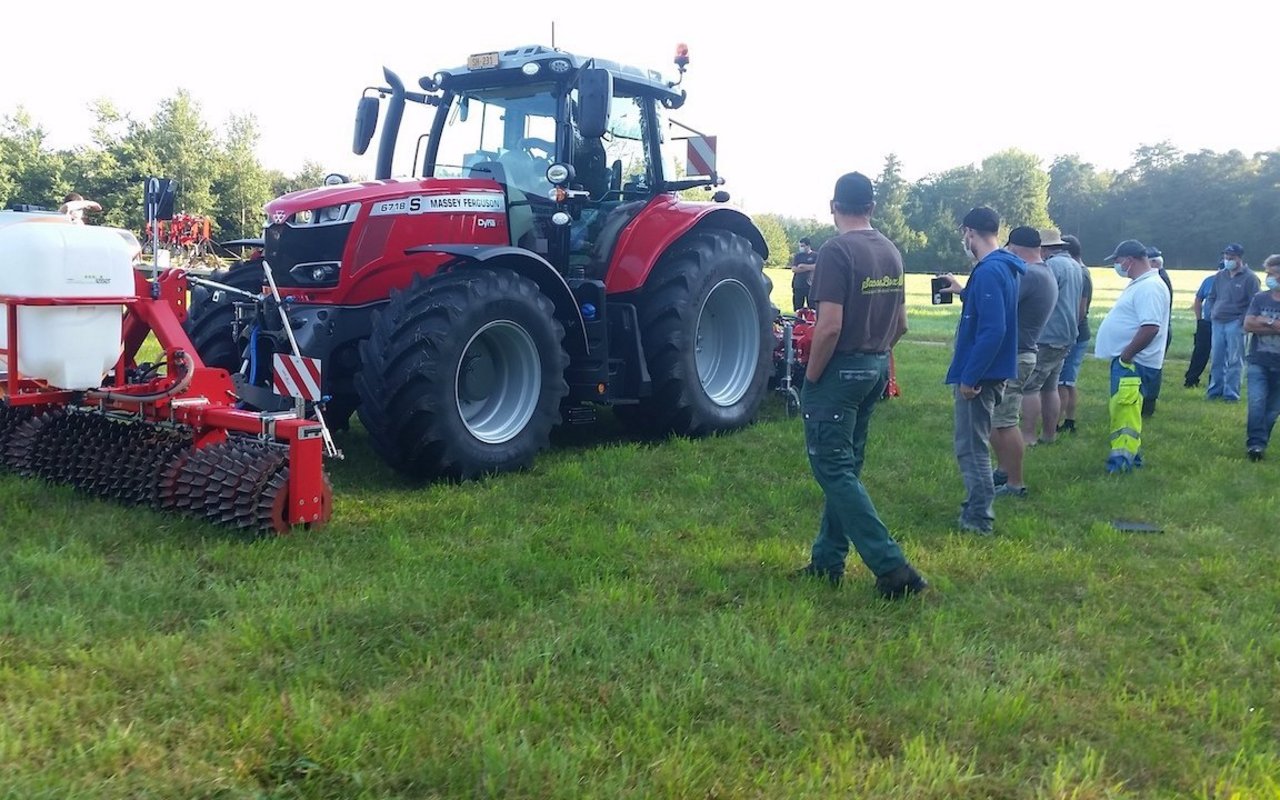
[431,84,558,197]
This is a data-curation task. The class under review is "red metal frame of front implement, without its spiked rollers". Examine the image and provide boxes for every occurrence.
[0,270,333,527]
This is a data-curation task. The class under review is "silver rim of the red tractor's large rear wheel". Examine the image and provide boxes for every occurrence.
[694,279,760,407]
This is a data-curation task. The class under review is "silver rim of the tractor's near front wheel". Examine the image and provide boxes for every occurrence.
[454,320,543,444]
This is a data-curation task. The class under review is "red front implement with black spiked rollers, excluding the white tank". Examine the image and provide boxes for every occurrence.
[0,264,333,532]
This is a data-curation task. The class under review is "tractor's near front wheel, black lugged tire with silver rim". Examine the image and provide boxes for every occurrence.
[356,269,568,480]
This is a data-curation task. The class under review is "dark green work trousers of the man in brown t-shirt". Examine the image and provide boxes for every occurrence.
[800,353,906,577]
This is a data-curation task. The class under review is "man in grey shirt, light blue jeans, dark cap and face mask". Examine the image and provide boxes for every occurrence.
[1206,242,1261,403]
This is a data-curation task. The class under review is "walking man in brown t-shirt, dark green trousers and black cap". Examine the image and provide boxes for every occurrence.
[796,173,928,599]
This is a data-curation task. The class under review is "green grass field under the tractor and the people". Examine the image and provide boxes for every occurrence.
[0,270,1280,800]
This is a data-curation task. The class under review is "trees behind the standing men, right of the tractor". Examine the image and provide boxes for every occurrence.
[755,148,1280,271]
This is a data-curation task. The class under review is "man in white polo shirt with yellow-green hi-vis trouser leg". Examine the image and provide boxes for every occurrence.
[1094,239,1170,472]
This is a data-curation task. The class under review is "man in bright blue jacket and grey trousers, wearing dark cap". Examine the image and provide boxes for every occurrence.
[946,207,1027,535]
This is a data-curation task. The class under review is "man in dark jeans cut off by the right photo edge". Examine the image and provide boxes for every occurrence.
[1244,255,1280,461]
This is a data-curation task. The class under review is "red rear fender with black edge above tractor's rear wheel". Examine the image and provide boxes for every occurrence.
[604,200,769,294]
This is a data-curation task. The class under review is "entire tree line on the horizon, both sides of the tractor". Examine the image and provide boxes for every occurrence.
[0,91,1280,266]
